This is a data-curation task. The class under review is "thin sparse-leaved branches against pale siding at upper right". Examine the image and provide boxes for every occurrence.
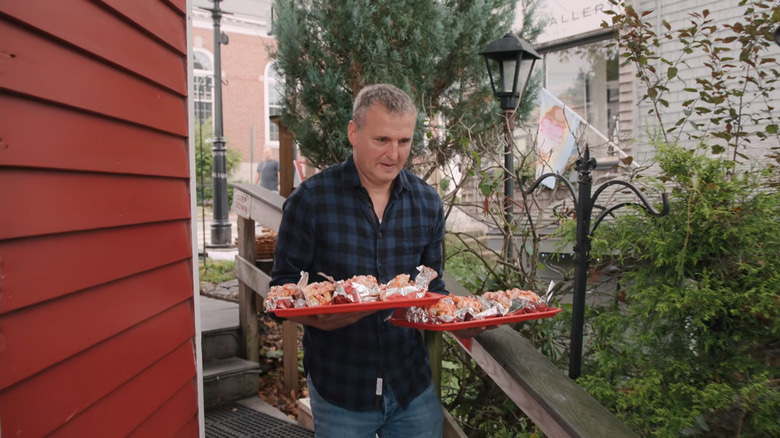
[602,0,780,164]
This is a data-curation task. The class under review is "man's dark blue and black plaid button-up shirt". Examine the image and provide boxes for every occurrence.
[271,156,447,411]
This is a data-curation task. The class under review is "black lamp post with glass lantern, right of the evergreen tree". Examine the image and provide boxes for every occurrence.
[479,32,540,262]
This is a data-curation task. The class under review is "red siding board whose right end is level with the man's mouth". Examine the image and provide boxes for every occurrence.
[0,94,190,178]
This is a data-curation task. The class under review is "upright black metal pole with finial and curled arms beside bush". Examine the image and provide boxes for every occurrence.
[569,146,596,379]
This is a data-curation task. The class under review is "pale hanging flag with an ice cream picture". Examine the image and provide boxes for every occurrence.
[536,88,582,188]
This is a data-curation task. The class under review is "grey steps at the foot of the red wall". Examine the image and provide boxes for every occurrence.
[200,296,262,408]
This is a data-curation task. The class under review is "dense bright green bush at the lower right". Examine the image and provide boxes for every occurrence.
[578,144,780,437]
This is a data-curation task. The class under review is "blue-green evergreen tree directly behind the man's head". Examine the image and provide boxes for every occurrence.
[273,0,516,173]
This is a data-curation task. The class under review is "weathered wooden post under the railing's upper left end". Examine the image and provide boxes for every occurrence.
[237,216,260,363]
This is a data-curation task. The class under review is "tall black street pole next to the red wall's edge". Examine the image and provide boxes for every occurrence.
[211,0,231,246]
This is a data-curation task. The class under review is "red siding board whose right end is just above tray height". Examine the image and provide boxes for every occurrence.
[0,222,192,315]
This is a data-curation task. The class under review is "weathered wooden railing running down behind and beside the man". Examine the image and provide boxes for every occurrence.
[233,184,636,438]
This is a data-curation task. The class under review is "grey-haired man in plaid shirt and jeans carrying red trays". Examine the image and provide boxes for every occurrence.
[271,84,479,438]
